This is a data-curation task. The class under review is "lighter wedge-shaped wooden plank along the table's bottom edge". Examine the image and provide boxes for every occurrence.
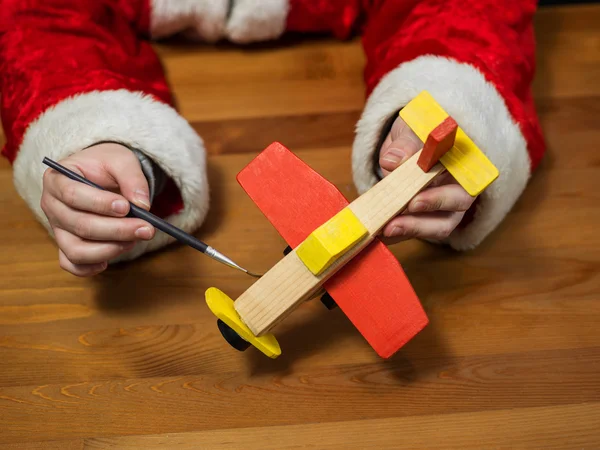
[85,403,600,450]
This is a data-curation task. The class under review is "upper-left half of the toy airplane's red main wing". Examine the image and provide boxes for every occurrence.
[237,142,348,248]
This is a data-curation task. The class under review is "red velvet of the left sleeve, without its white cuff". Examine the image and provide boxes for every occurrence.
[0,0,181,216]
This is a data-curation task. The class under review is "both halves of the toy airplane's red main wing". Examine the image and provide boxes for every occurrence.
[237,143,428,358]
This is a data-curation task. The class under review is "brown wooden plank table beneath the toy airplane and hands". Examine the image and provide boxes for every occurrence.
[0,6,600,450]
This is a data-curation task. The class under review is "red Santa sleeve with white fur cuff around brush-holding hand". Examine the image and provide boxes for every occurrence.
[0,0,208,262]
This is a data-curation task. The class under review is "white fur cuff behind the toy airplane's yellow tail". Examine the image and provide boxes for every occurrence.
[352,56,531,250]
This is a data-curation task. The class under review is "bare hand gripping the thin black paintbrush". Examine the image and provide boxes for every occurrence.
[41,144,155,277]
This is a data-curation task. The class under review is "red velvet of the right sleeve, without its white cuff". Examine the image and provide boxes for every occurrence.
[287,0,545,169]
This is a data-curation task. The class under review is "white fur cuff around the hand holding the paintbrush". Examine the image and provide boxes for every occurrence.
[14,90,209,260]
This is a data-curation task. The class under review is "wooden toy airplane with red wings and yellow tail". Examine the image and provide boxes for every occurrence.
[206,91,498,358]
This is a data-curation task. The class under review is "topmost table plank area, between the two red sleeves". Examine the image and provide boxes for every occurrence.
[158,40,365,122]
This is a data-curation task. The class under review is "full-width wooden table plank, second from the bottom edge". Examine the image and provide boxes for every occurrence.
[0,347,600,444]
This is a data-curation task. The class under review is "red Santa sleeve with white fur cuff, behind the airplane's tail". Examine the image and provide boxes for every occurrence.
[287,0,545,249]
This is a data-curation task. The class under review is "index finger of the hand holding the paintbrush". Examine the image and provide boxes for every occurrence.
[44,174,129,217]
